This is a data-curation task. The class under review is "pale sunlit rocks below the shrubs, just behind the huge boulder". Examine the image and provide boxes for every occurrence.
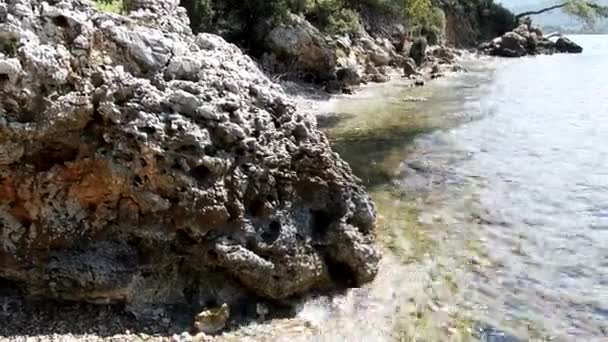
[261,15,452,93]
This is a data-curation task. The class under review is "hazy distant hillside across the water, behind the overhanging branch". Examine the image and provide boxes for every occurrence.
[500,0,608,33]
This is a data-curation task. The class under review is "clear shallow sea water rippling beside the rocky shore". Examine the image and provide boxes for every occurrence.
[308,36,608,341]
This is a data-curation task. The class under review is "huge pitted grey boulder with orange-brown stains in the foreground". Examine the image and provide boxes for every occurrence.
[0,0,379,318]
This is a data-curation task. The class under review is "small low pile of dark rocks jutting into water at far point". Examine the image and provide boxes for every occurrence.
[479,22,583,57]
